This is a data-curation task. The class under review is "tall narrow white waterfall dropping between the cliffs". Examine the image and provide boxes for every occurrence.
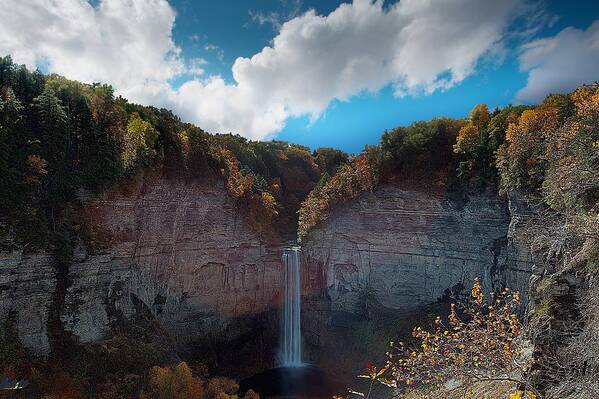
[280,247,302,367]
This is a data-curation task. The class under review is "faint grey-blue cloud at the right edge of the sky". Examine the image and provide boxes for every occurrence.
[517,20,599,101]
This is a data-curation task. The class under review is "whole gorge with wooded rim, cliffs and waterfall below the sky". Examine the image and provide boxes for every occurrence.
[0,57,599,399]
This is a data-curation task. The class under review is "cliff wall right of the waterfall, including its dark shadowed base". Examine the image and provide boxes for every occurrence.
[302,185,532,372]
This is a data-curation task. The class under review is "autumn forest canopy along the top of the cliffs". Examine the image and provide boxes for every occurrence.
[0,57,599,247]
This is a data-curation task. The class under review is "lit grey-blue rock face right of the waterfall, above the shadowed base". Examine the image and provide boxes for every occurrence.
[303,186,530,314]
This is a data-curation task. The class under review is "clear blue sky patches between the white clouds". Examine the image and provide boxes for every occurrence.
[172,0,599,152]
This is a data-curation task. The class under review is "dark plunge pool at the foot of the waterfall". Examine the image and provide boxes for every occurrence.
[239,366,345,399]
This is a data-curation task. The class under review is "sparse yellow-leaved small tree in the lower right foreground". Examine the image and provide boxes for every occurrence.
[361,279,536,398]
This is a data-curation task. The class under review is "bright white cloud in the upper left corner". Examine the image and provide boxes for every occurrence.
[0,0,184,101]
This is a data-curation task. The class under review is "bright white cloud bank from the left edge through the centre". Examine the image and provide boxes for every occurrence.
[0,0,522,139]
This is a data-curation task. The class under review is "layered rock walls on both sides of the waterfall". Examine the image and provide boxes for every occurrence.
[0,176,533,375]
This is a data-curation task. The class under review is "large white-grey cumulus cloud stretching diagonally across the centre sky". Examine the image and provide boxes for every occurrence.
[171,0,519,138]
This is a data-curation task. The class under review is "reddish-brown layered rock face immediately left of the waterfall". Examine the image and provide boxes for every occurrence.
[63,179,281,343]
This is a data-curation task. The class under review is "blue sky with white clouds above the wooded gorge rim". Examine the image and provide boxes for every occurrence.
[0,0,599,153]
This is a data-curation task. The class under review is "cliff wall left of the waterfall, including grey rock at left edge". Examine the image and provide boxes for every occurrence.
[0,178,281,376]
